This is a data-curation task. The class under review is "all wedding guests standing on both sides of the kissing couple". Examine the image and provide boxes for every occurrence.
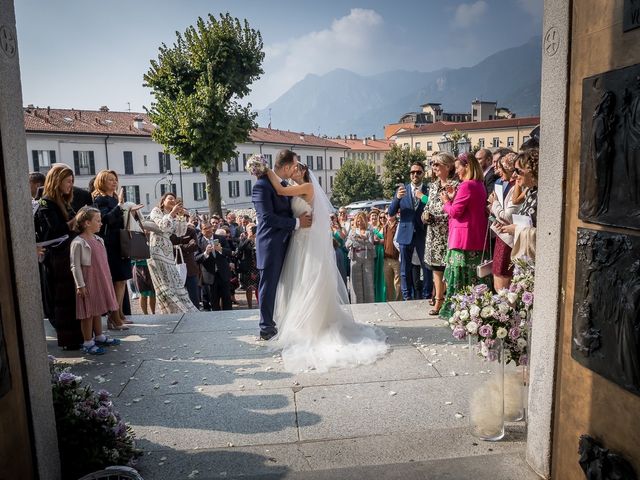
[29,131,538,354]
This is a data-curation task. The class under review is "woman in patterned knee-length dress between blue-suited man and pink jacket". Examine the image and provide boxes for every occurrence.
[420,152,458,315]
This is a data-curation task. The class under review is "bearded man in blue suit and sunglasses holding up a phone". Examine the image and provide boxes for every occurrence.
[389,161,433,300]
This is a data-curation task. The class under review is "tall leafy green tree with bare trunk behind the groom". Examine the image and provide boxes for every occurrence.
[144,13,264,214]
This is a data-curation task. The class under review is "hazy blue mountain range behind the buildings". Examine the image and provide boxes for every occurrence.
[258,37,542,137]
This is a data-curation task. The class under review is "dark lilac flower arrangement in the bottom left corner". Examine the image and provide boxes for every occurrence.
[49,357,142,478]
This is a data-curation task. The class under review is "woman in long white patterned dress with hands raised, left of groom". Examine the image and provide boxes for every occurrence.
[148,192,198,313]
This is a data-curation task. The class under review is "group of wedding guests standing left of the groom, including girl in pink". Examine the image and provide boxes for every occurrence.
[29,163,259,355]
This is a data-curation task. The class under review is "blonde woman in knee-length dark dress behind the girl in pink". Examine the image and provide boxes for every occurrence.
[92,170,142,330]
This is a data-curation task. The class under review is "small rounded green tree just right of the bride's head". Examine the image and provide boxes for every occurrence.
[331,160,382,206]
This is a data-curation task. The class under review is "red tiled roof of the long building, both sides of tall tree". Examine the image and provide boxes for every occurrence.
[24,108,344,149]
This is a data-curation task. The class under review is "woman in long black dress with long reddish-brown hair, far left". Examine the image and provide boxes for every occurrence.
[34,163,83,349]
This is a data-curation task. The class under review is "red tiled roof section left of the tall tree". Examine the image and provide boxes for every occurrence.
[24,108,154,137]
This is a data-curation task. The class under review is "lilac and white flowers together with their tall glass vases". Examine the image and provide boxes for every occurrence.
[449,258,534,440]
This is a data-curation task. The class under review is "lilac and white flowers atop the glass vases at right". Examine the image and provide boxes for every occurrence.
[449,259,534,365]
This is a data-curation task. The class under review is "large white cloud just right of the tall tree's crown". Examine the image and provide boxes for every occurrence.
[250,8,385,108]
